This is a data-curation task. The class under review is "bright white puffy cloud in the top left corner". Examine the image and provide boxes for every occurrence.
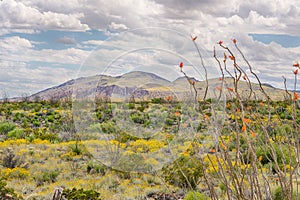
[0,0,89,31]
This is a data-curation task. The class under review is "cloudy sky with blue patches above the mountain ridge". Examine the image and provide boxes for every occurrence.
[0,0,300,97]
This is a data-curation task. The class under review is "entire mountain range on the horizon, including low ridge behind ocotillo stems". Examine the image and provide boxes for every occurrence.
[29,71,285,101]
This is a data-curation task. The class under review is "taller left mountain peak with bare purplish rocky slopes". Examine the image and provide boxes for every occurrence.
[29,71,171,100]
